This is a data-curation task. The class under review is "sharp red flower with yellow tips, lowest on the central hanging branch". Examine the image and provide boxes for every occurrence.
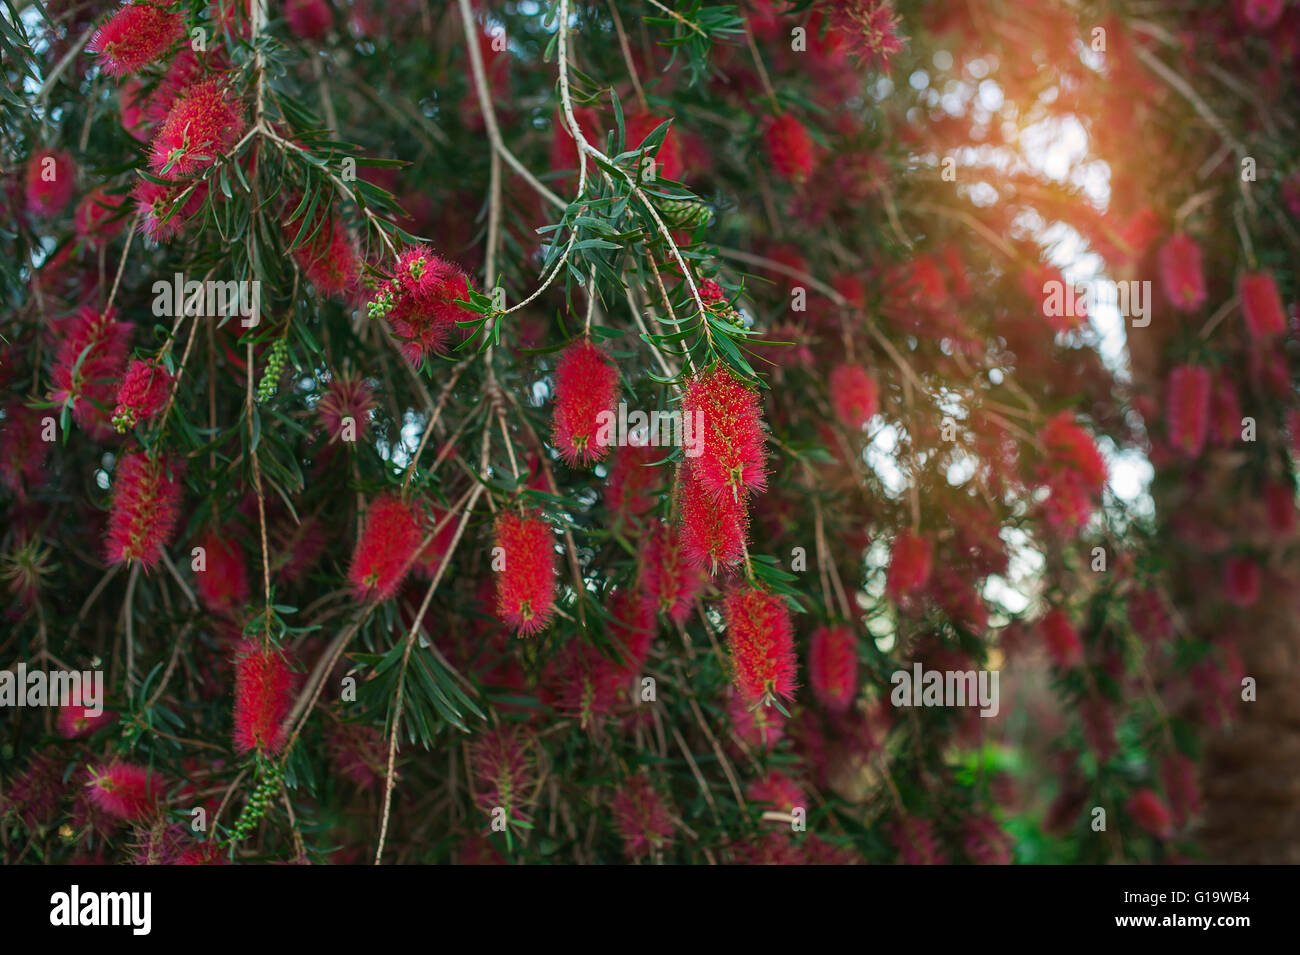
[723,583,798,703]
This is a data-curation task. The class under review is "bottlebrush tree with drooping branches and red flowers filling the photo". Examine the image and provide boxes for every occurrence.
[0,0,1300,864]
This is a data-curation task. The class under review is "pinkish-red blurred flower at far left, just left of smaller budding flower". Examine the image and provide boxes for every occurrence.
[52,308,131,440]
